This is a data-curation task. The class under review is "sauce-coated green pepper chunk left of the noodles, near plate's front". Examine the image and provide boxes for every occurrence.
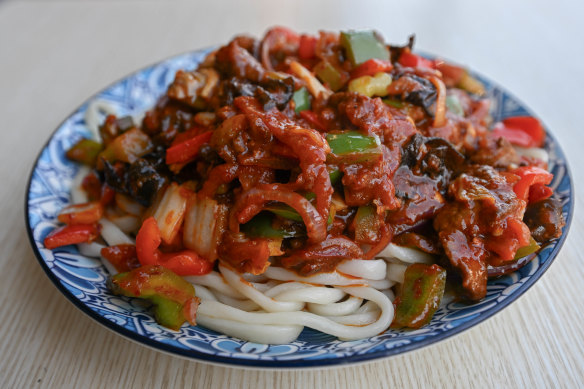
[109,265,200,330]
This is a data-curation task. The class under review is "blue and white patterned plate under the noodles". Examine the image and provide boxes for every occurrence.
[26,50,574,368]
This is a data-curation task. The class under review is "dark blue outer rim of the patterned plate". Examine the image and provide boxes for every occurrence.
[24,47,575,370]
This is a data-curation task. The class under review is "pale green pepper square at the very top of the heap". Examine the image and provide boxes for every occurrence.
[341,31,389,66]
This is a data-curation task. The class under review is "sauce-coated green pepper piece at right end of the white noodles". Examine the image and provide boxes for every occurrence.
[391,263,446,328]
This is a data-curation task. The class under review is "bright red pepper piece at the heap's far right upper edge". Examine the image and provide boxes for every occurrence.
[493,116,545,147]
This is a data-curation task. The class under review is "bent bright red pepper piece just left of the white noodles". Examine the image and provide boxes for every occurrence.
[136,217,213,276]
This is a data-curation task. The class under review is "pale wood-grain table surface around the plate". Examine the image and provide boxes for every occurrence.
[0,0,584,388]
